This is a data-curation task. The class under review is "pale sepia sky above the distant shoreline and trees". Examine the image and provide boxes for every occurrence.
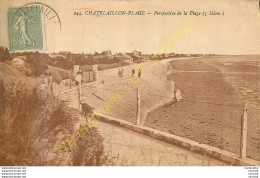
[0,0,260,54]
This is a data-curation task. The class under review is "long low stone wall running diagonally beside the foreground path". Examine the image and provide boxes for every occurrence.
[94,112,260,166]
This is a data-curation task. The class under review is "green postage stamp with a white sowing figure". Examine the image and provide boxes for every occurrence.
[7,6,44,52]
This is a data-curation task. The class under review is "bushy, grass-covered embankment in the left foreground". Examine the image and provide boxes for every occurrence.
[0,62,103,166]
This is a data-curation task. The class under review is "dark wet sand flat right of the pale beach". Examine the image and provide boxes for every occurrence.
[146,56,260,160]
